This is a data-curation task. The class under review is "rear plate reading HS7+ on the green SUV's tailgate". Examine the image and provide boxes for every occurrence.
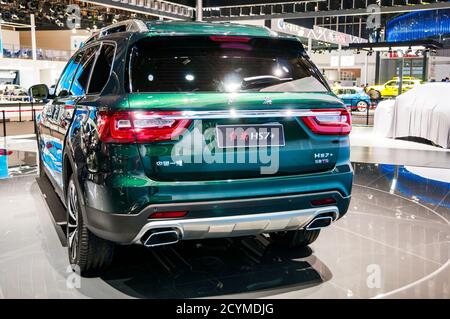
[216,124,285,148]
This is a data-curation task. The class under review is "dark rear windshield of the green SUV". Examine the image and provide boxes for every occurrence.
[128,36,329,92]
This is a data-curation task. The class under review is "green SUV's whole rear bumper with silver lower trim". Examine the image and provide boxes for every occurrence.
[85,191,350,244]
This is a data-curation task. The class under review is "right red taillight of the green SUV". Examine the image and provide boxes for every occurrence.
[302,109,352,135]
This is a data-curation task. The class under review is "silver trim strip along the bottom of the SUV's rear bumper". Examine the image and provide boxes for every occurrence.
[133,206,339,243]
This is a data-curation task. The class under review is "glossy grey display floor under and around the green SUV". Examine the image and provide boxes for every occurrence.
[0,163,450,298]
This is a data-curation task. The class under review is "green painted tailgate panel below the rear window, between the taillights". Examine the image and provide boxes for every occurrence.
[129,93,343,181]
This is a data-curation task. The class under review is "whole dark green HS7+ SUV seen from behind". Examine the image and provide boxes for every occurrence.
[30,20,353,275]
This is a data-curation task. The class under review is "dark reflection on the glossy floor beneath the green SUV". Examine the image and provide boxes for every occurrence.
[98,236,332,298]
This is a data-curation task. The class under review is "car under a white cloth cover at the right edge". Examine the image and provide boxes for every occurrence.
[387,82,450,148]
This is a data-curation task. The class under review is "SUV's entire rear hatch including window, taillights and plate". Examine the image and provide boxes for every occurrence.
[124,36,349,181]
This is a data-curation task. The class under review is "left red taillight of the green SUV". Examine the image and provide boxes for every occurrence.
[97,111,191,143]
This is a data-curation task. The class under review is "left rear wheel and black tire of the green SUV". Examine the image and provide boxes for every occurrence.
[66,175,114,276]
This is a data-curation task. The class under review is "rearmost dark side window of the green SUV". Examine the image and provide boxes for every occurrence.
[88,43,116,94]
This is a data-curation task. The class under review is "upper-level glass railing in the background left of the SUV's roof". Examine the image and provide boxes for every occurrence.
[3,43,71,61]
